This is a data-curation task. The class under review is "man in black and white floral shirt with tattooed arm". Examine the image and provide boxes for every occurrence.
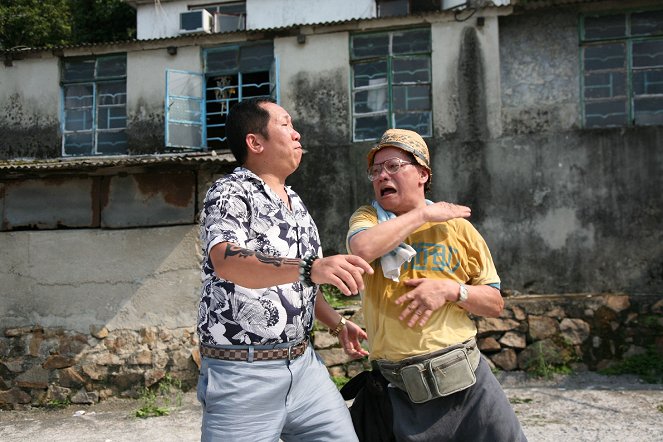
[198,99,372,442]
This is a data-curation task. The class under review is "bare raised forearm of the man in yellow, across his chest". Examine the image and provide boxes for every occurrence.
[350,210,425,262]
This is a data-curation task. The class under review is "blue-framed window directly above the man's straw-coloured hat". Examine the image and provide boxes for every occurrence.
[350,28,432,141]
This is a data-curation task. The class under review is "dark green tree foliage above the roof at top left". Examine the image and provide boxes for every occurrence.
[0,0,136,50]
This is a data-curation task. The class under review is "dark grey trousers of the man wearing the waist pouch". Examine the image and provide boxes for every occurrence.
[388,357,527,442]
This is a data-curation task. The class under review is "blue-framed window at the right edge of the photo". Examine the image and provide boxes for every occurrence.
[580,10,663,128]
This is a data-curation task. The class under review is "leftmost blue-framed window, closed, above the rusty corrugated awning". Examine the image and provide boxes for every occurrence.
[61,54,127,156]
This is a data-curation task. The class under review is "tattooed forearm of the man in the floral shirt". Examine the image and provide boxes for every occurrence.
[210,242,299,289]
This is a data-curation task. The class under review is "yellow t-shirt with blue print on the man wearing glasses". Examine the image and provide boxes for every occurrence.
[347,206,500,361]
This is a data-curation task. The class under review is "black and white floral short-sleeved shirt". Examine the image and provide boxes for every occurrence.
[198,167,322,345]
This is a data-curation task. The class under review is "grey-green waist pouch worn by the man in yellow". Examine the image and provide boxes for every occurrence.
[377,338,481,403]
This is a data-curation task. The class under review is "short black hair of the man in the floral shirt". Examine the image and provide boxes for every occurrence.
[226,97,276,166]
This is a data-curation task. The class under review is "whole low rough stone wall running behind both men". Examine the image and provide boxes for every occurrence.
[0,294,663,409]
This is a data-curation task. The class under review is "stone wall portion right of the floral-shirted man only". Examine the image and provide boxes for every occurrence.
[315,294,663,377]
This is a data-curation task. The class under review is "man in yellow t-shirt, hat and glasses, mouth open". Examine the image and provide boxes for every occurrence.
[347,129,526,442]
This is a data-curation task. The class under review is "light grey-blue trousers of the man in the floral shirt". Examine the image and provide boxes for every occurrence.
[198,345,357,442]
